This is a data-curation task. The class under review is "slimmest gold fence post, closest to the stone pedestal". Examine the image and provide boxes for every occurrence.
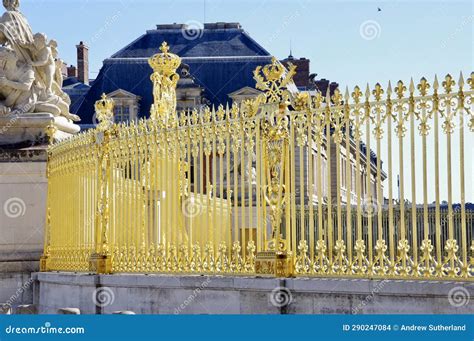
[89,94,114,274]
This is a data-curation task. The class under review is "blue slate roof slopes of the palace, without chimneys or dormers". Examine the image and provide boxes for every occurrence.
[75,24,271,124]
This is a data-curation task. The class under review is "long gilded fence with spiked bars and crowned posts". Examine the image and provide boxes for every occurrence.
[41,44,474,280]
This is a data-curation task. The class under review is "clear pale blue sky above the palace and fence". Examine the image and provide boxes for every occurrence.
[16,0,474,202]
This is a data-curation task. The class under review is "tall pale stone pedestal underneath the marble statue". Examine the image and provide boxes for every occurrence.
[0,113,80,307]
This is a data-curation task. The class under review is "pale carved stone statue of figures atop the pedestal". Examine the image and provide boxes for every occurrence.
[0,0,80,121]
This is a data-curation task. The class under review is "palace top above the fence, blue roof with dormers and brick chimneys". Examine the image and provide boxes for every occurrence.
[64,23,338,127]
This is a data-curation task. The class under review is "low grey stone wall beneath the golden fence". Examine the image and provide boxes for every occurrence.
[34,273,474,314]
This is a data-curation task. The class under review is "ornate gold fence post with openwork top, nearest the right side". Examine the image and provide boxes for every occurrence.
[254,58,296,277]
